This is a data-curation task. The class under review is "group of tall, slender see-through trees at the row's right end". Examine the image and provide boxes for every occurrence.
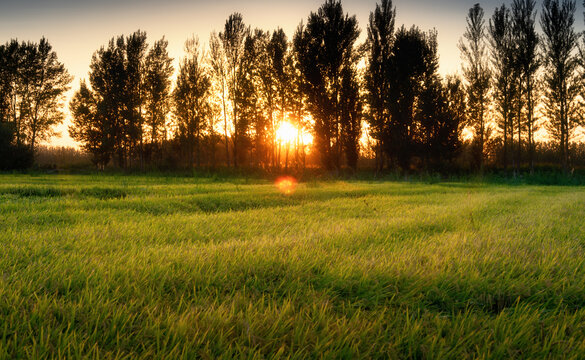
[459,0,585,172]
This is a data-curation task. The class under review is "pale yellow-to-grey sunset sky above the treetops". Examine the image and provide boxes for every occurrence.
[0,0,583,145]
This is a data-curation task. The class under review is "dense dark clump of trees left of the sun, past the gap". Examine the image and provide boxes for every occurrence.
[70,31,172,168]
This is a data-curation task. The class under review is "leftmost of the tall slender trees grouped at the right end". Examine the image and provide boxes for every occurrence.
[459,4,490,169]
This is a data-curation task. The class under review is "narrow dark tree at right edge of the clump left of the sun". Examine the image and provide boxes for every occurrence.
[144,37,173,163]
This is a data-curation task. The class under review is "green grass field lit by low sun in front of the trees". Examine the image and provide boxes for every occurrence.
[0,175,585,359]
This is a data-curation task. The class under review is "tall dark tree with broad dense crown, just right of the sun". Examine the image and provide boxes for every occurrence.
[294,0,359,169]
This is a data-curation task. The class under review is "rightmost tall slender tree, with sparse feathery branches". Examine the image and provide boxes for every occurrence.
[540,0,580,172]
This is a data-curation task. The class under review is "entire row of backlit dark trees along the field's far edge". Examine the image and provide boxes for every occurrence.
[0,0,585,172]
